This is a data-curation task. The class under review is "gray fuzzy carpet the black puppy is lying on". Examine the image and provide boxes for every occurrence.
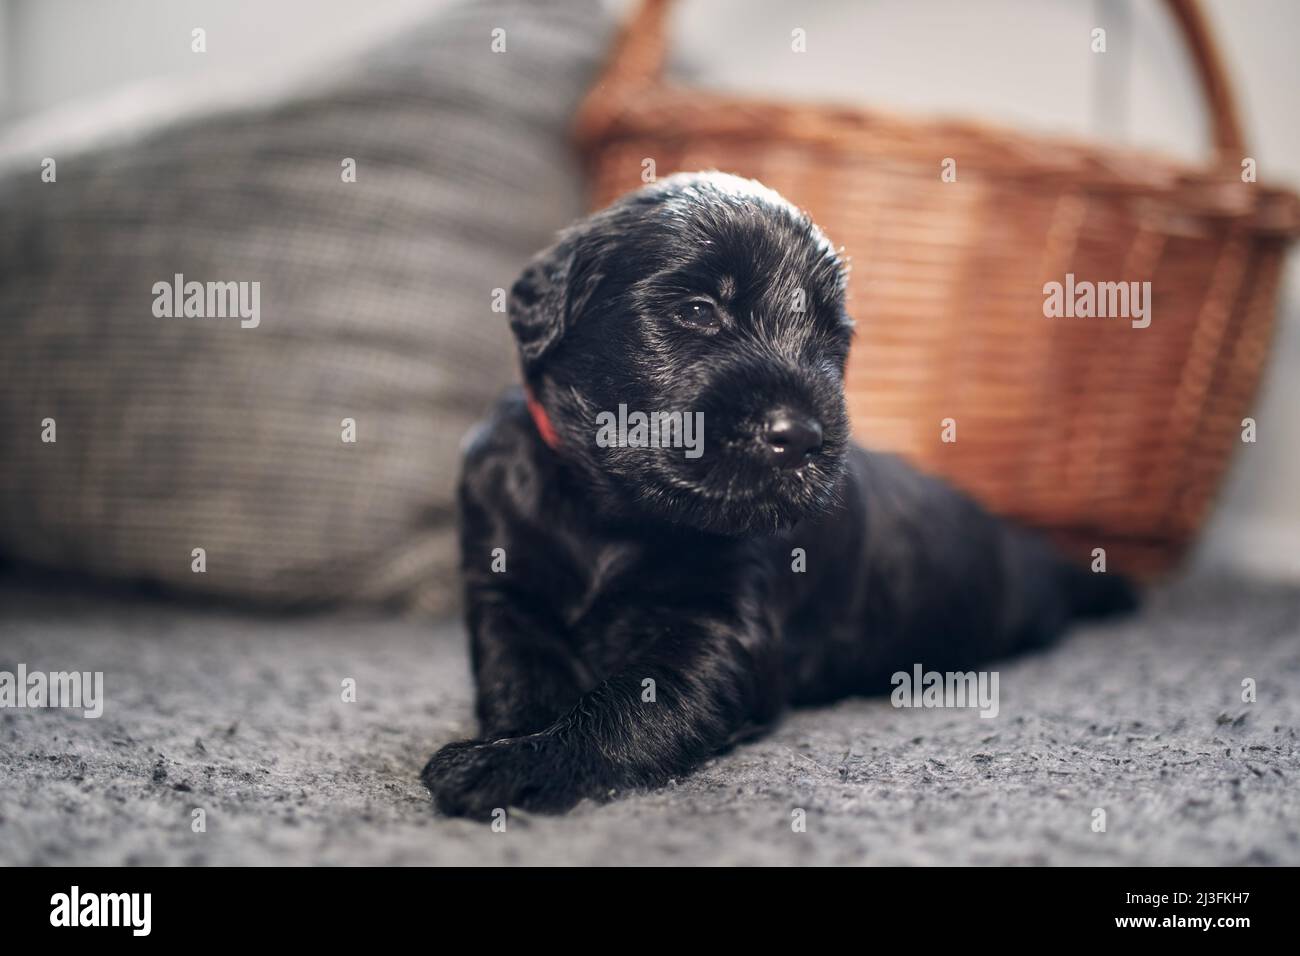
[0,580,1300,865]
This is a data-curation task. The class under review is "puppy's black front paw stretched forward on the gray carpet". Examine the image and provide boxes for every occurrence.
[420,734,599,819]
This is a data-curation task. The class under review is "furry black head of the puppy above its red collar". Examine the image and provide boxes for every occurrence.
[508,173,853,535]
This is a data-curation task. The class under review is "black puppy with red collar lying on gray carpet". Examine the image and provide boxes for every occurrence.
[424,174,1132,816]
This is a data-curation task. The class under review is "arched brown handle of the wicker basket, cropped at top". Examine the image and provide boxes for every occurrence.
[584,0,1245,159]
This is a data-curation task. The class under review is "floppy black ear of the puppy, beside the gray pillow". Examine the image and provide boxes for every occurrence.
[507,235,601,368]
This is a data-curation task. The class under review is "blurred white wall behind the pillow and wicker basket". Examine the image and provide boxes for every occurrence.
[0,0,1300,579]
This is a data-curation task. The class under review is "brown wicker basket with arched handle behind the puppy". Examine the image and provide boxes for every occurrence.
[577,0,1300,575]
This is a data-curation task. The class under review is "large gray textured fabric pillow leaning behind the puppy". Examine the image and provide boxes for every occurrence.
[0,0,610,610]
